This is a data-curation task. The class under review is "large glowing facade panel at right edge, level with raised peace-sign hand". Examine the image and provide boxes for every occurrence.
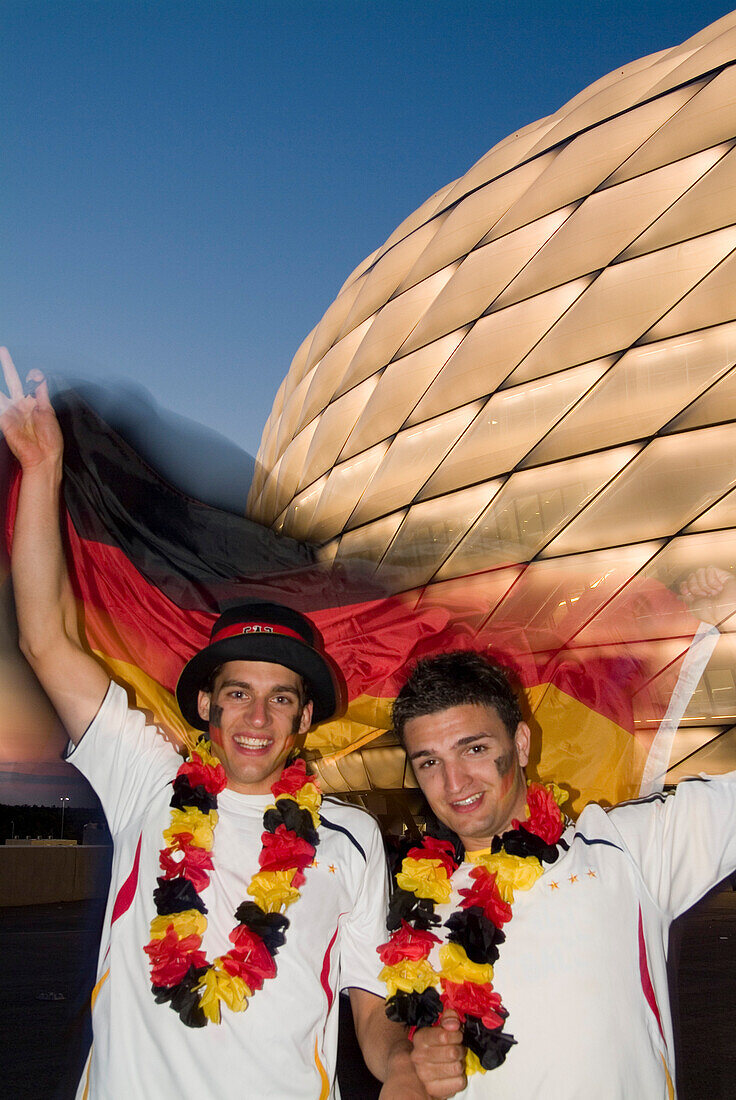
[521,326,736,464]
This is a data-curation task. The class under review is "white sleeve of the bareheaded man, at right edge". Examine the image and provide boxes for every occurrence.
[607,772,736,919]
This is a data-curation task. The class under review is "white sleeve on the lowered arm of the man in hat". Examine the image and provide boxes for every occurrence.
[340,820,388,997]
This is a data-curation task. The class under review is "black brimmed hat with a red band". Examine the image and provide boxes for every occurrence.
[176,603,338,730]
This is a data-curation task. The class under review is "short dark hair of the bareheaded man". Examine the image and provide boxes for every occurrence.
[392,649,521,745]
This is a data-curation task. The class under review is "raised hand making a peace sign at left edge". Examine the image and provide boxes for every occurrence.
[0,348,64,470]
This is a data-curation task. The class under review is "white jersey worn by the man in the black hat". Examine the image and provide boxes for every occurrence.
[69,684,386,1100]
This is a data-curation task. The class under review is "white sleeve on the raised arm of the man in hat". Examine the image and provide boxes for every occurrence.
[67,682,180,836]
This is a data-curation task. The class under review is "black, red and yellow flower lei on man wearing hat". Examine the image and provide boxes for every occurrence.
[143,736,321,1027]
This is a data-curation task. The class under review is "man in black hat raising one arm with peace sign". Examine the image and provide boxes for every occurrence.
[0,350,426,1100]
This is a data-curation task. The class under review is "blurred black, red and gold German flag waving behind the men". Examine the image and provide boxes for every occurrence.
[0,392,697,810]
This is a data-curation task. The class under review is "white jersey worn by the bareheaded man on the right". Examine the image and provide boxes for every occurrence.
[431,773,736,1100]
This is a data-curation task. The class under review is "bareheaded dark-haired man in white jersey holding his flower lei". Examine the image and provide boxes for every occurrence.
[380,651,736,1100]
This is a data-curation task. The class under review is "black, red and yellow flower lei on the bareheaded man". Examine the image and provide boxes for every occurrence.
[378,783,567,1076]
